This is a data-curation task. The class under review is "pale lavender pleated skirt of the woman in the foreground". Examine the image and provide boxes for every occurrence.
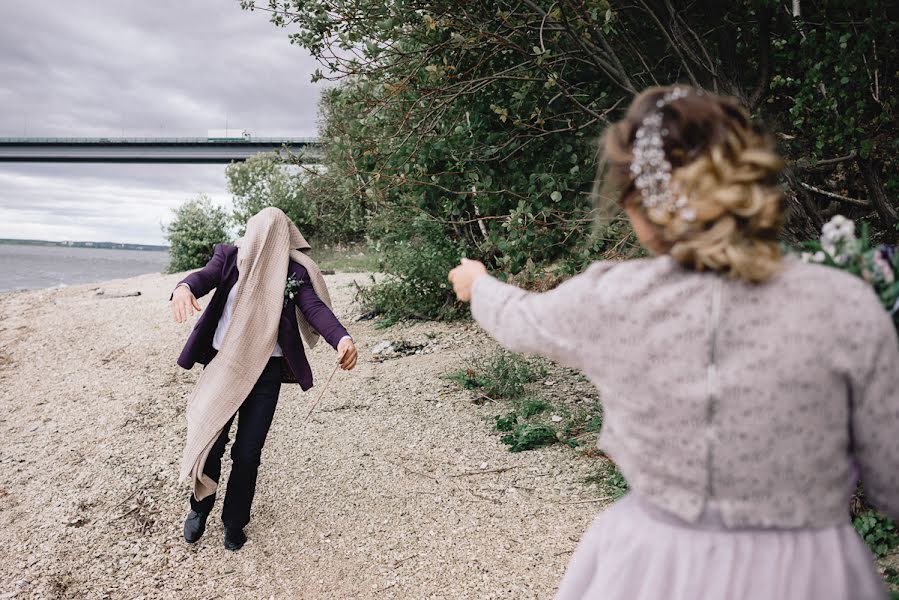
[556,494,886,600]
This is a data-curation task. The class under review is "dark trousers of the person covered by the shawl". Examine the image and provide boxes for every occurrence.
[190,358,281,528]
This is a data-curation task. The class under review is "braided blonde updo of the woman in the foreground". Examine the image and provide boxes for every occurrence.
[598,86,786,282]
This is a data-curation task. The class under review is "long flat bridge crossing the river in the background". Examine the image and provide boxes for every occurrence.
[0,138,321,164]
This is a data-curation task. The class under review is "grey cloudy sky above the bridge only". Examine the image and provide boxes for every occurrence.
[0,0,318,135]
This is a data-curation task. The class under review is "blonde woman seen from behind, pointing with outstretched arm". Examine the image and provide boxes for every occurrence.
[450,87,899,600]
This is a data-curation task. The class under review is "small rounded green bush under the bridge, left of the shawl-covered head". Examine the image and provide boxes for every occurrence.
[163,195,229,273]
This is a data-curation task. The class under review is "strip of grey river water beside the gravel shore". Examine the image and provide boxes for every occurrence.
[0,244,169,292]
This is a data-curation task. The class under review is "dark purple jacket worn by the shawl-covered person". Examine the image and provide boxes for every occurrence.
[178,244,349,391]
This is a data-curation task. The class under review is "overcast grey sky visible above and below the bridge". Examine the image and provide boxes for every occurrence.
[0,0,319,244]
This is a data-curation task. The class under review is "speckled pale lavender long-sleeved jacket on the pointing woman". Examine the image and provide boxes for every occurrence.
[472,257,899,528]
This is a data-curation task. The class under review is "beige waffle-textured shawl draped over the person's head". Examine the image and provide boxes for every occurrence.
[180,207,331,500]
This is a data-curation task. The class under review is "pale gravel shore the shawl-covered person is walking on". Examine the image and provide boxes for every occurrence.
[0,274,602,600]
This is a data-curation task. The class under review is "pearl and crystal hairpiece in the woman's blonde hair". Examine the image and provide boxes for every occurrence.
[630,87,696,222]
